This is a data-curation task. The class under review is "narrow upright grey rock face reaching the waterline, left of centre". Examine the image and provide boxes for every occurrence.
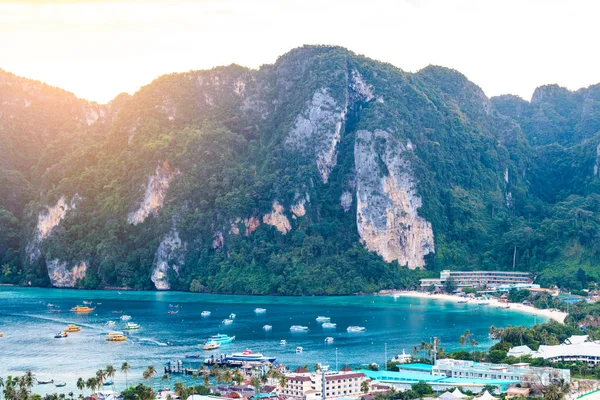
[150,227,187,290]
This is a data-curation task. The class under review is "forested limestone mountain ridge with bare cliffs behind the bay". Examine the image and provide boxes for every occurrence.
[0,46,600,295]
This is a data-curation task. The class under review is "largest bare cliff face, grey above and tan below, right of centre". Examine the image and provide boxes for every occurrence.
[354,130,434,269]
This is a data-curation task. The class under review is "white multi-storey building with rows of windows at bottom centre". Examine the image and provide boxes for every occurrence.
[277,367,367,400]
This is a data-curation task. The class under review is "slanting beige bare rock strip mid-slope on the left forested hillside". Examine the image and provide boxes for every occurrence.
[127,161,180,225]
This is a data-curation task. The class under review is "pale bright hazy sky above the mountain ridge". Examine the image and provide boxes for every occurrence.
[0,0,600,103]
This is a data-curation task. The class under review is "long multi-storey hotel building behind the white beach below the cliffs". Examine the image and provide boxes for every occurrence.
[421,269,533,289]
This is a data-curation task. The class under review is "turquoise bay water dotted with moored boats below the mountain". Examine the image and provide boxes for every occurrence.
[0,287,543,393]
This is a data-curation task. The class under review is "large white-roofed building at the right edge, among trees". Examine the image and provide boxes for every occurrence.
[507,335,600,365]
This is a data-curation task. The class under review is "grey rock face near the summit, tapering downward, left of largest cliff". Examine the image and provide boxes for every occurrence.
[286,88,348,183]
